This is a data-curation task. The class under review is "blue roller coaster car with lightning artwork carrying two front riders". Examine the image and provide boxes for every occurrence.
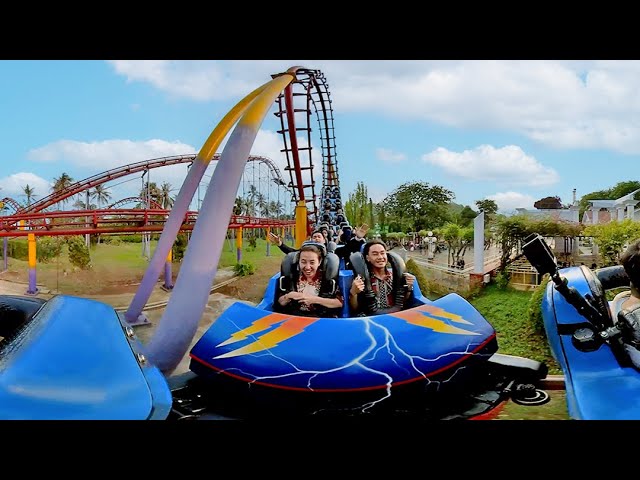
[172,246,549,419]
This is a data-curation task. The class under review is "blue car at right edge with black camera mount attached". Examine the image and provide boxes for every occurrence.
[523,234,640,420]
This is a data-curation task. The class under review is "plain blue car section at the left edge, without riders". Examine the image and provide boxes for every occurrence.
[0,295,172,420]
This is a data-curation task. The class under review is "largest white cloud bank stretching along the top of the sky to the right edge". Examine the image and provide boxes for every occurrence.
[110,60,640,153]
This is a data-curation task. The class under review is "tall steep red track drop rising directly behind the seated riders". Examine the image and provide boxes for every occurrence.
[275,68,343,232]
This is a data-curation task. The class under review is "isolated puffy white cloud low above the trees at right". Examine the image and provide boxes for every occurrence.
[422,145,559,187]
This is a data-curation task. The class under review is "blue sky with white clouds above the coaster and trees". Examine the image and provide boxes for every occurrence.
[0,60,640,214]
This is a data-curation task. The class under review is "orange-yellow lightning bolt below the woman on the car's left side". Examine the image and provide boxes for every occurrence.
[214,313,318,359]
